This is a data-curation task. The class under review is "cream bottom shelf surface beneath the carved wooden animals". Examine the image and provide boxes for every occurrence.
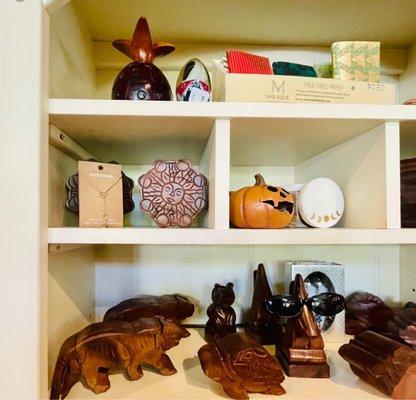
[63,329,386,400]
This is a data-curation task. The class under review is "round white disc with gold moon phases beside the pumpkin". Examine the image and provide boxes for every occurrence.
[298,178,344,228]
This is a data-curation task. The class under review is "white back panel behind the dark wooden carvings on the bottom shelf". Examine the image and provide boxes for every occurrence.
[95,245,400,324]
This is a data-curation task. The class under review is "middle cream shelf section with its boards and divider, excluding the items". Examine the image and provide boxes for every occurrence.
[49,99,416,233]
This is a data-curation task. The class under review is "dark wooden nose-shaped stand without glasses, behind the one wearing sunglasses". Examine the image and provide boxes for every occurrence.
[245,264,282,344]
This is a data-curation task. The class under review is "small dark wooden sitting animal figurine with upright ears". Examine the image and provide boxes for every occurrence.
[205,282,236,341]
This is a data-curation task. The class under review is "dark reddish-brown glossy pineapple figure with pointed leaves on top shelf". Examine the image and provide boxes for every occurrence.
[111,17,175,101]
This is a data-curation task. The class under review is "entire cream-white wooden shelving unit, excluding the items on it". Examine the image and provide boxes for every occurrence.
[0,0,416,399]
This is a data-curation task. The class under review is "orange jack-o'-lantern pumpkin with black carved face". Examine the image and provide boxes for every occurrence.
[230,174,294,229]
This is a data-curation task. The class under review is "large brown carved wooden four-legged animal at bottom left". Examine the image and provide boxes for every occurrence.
[50,317,189,399]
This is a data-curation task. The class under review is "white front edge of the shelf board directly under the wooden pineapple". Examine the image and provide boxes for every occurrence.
[49,99,416,123]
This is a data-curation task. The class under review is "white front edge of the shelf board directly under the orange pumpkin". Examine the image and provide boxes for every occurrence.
[49,228,416,245]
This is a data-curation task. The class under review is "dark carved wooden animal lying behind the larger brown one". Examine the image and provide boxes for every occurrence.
[104,294,195,322]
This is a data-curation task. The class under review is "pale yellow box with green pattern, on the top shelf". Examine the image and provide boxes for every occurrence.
[331,42,380,82]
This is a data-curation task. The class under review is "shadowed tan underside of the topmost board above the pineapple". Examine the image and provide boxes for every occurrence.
[75,0,416,48]
